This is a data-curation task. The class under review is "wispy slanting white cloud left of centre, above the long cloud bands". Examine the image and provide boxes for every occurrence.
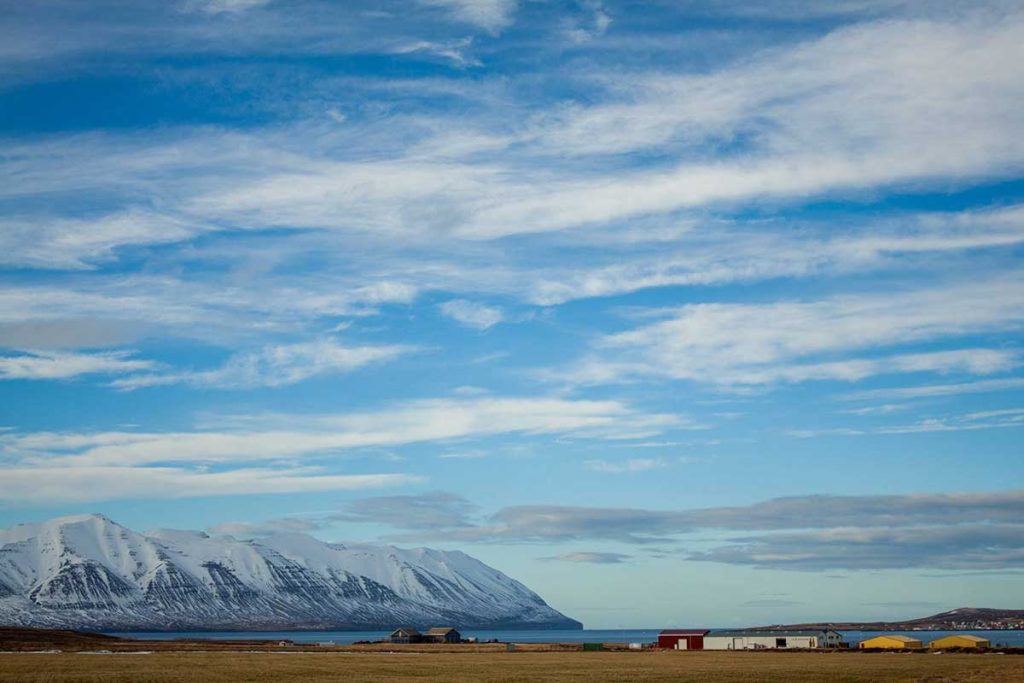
[112,339,414,389]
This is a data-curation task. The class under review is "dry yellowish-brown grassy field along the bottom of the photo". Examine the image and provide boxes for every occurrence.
[0,651,1024,683]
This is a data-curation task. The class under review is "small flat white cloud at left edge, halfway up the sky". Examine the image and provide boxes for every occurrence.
[0,351,157,380]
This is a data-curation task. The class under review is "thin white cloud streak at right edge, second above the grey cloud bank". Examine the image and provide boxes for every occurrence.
[524,206,1024,305]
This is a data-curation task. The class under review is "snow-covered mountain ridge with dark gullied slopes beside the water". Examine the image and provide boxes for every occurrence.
[0,515,582,630]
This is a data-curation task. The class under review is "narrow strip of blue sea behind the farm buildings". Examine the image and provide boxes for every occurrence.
[101,629,1024,647]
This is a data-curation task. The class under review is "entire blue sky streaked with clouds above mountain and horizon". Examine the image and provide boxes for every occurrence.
[0,0,1024,628]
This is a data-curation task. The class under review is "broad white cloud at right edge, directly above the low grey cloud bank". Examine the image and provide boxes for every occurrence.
[569,276,1024,385]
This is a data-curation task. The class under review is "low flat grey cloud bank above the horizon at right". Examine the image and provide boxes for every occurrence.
[339,490,1024,570]
